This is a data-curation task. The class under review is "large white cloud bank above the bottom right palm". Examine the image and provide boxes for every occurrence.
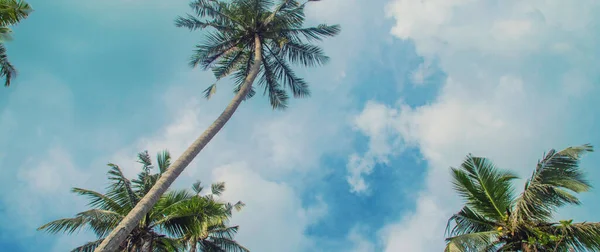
[350,0,600,251]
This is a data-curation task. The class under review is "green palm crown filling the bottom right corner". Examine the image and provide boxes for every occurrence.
[445,145,600,252]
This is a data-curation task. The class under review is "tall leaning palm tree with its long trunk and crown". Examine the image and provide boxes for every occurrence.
[96,0,340,252]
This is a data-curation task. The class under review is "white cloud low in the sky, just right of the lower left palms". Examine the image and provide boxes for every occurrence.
[213,163,326,251]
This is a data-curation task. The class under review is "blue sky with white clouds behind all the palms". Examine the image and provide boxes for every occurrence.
[0,0,600,252]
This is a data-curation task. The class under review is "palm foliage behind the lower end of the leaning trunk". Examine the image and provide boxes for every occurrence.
[38,151,243,252]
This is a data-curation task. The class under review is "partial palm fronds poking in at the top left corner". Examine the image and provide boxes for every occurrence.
[0,0,32,87]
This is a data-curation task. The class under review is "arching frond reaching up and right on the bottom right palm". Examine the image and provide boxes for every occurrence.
[515,144,593,221]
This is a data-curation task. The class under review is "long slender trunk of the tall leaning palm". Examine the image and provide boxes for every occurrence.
[94,35,262,252]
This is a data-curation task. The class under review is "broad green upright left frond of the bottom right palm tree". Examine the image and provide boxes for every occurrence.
[451,155,517,221]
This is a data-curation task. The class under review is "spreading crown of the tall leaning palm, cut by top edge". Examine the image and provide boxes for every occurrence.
[176,0,340,109]
